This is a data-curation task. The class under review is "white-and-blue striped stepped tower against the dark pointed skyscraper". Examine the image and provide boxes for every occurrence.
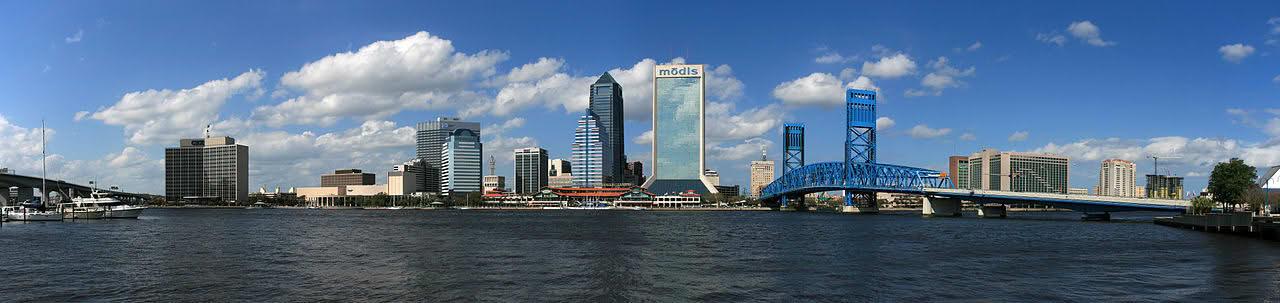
[571,109,612,188]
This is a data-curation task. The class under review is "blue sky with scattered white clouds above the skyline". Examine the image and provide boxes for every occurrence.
[0,1,1280,193]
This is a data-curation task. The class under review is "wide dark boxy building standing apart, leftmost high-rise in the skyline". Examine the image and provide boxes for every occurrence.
[164,137,248,203]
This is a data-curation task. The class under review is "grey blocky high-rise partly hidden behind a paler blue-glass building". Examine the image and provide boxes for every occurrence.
[416,116,480,193]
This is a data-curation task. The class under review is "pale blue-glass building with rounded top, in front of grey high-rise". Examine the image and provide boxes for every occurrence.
[440,128,483,194]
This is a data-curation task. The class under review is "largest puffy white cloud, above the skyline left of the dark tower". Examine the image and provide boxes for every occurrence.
[253,32,506,125]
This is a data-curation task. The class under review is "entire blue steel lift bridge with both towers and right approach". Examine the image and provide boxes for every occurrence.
[760,89,1189,217]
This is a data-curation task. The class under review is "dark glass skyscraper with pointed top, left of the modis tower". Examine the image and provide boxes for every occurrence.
[588,73,626,183]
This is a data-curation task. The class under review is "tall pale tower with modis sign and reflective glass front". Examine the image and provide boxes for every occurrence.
[644,64,716,194]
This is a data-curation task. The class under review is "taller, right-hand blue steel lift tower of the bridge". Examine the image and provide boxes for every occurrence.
[845,88,878,212]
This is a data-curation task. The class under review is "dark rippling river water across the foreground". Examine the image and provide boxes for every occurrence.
[0,210,1280,302]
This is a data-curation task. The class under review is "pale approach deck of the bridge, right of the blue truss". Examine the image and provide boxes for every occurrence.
[924,188,1190,211]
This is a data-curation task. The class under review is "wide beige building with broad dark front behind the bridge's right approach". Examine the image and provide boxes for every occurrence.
[969,148,1071,194]
